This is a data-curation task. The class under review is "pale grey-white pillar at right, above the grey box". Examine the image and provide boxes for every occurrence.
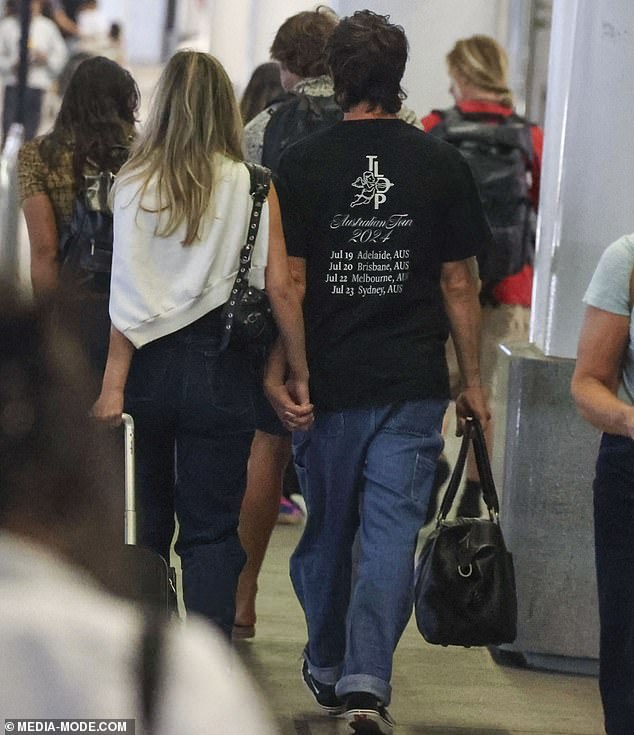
[531,0,634,357]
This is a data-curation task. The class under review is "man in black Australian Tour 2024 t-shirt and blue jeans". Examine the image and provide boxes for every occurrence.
[266,11,491,733]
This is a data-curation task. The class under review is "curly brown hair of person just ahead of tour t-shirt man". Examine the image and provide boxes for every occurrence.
[271,5,338,79]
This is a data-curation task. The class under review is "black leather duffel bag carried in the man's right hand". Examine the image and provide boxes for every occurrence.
[415,418,517,646]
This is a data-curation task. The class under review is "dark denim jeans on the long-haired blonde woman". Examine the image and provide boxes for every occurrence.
[125,329,255,635]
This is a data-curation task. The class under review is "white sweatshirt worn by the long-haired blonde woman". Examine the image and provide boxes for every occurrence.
[110,155,269,348]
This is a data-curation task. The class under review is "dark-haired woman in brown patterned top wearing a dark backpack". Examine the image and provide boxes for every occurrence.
[18,56,139,388]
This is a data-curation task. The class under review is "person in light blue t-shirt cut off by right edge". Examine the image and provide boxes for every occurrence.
[572,235,634,735]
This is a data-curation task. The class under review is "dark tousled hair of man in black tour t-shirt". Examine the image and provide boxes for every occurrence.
[326,10,408,113]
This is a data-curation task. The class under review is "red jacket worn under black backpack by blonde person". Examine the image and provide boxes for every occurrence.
[421,100,544,306]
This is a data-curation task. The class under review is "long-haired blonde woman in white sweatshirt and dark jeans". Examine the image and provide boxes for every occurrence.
[93,51,312,635]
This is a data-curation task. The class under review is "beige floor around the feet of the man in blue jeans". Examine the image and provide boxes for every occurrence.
[233,526,603,735]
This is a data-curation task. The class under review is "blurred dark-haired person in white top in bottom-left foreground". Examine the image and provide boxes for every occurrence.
[0,284,275,735]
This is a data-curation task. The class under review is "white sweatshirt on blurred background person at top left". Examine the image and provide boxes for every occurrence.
[0,15,68,90]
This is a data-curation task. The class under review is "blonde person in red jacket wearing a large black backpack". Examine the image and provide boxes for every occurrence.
[422,35,543,517]
